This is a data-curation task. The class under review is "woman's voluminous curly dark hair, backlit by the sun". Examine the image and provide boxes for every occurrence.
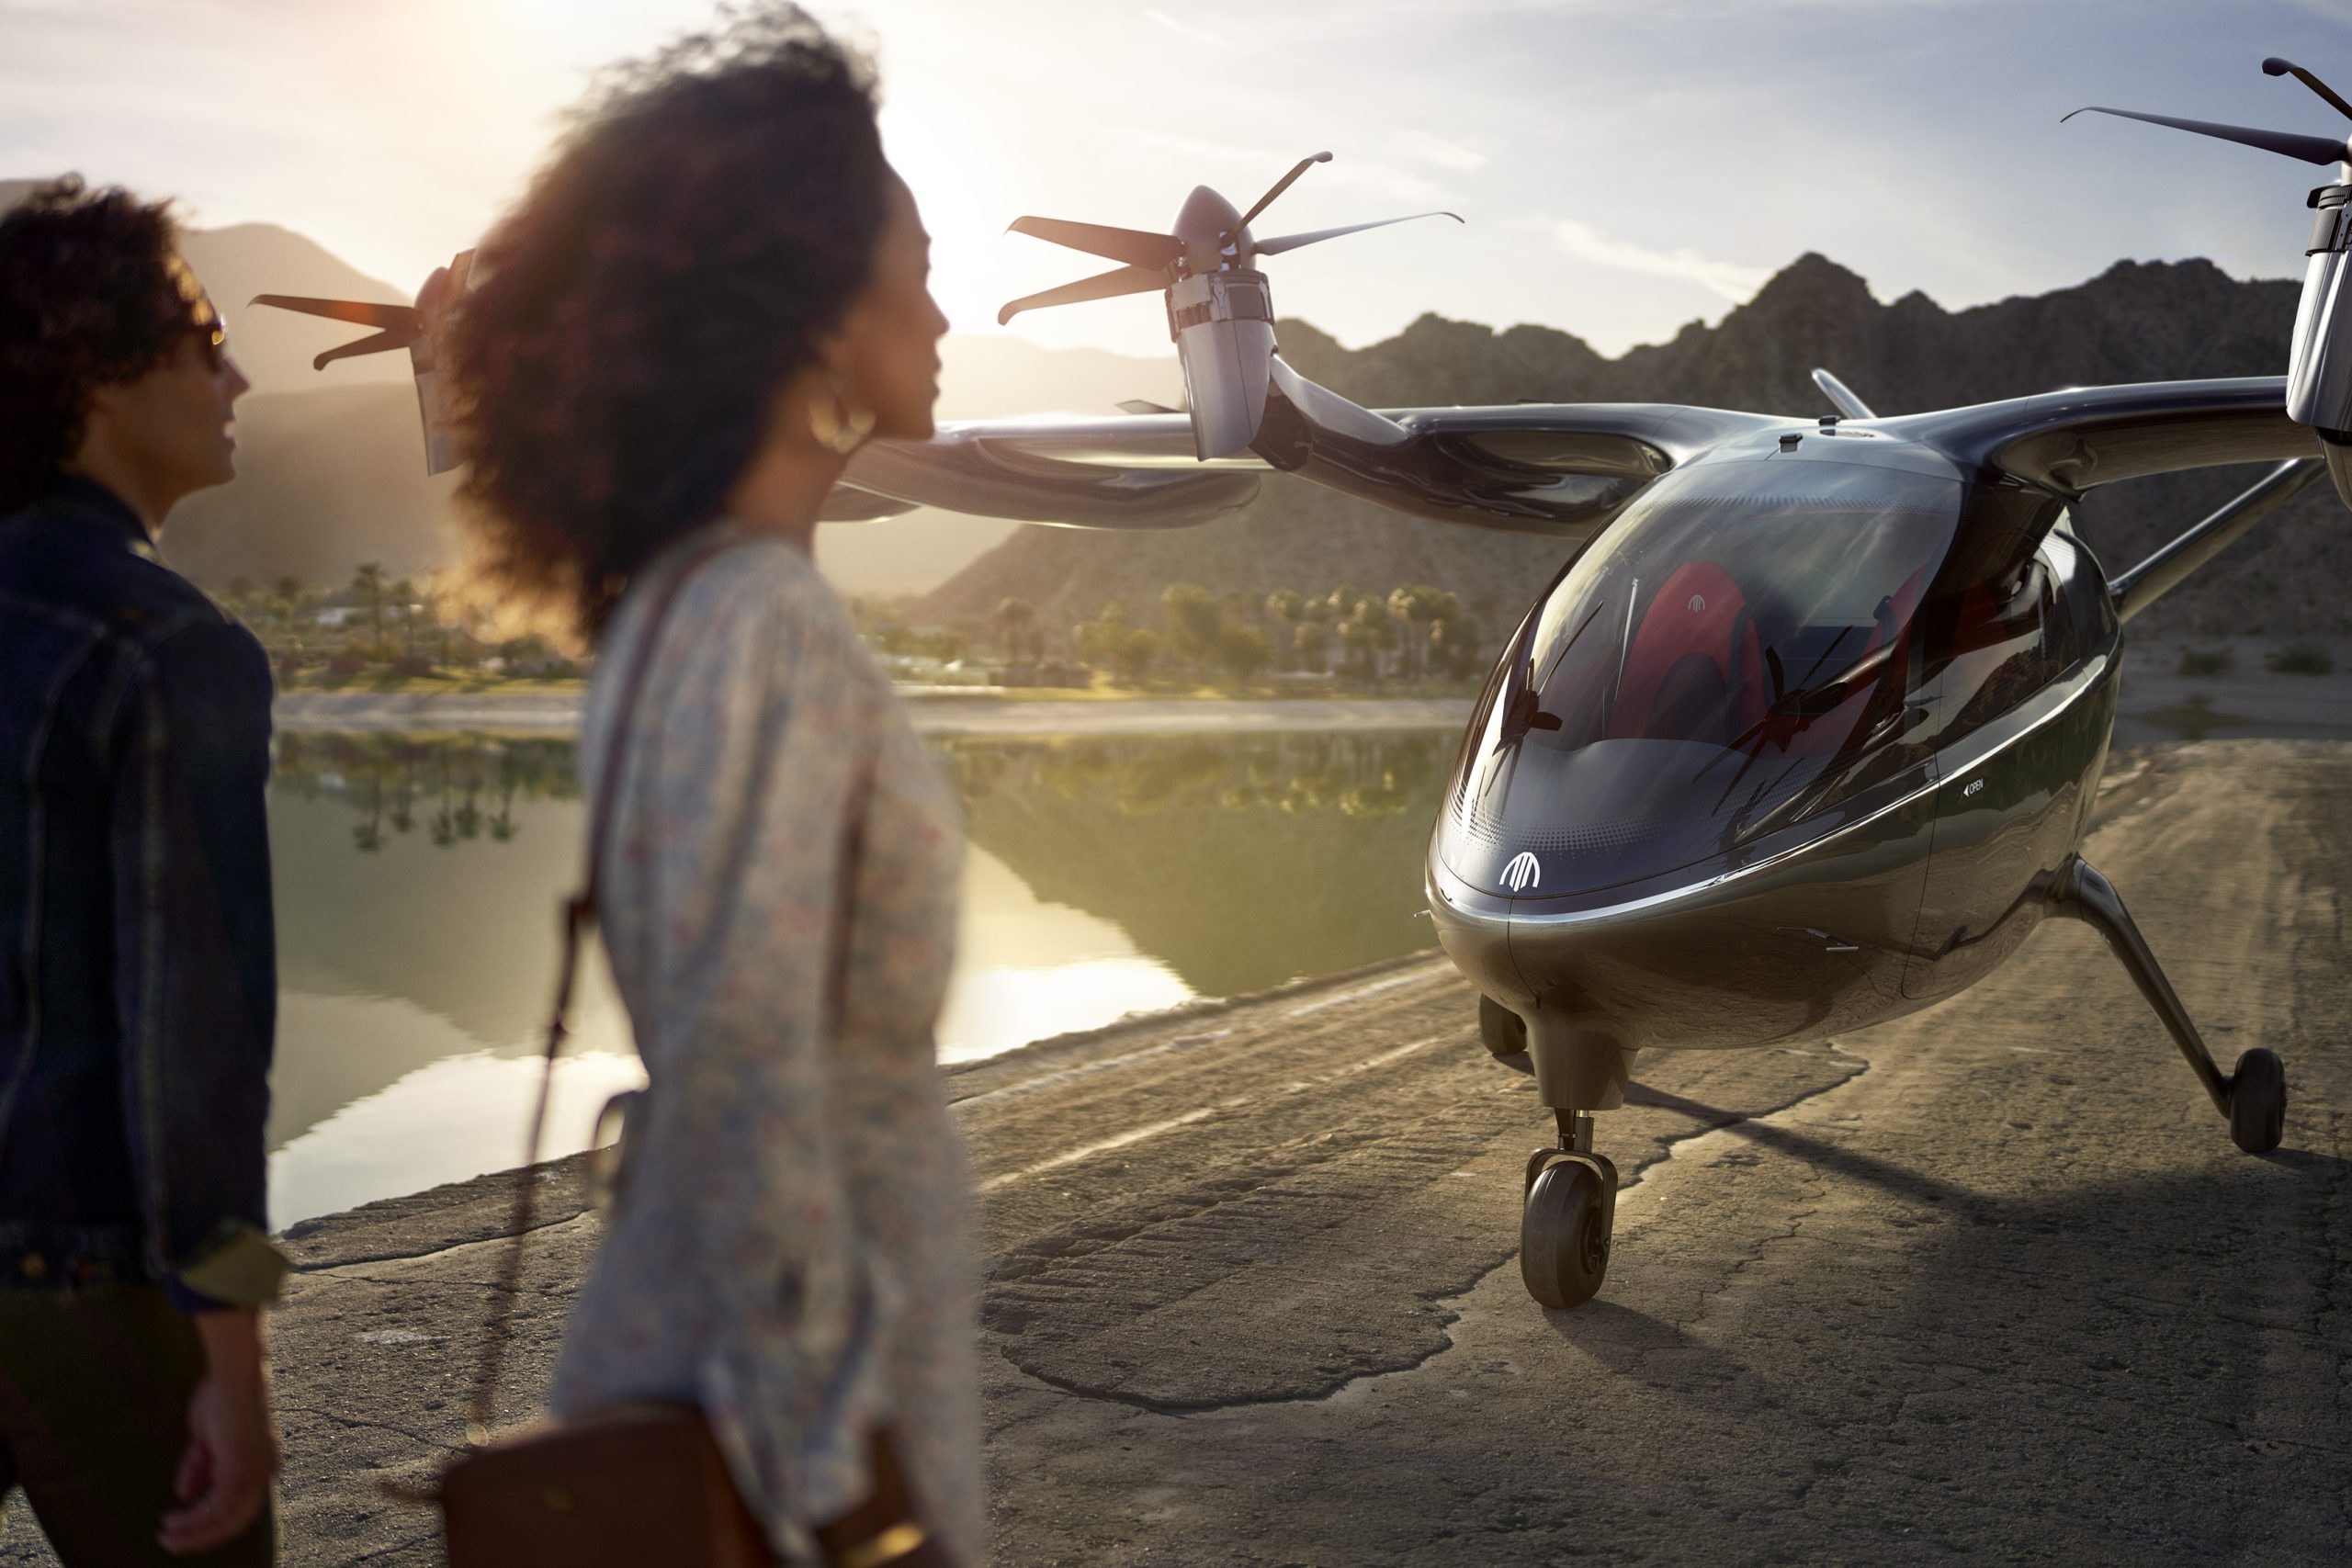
[445,5,887,642]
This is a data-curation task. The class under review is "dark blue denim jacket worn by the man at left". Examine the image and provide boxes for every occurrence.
[0,478,285,1309]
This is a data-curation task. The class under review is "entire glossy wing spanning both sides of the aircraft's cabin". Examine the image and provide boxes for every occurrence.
[828,373,2322,541]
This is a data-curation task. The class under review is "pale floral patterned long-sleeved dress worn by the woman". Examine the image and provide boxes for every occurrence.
[550,525,988,1563]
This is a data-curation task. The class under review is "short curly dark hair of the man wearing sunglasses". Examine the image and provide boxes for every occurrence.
[0,174,190,513]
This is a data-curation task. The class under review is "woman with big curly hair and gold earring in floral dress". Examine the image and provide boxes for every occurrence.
[447,7,986,1565]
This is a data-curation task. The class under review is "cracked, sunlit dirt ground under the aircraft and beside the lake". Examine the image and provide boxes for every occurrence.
[0,740,2352,1565]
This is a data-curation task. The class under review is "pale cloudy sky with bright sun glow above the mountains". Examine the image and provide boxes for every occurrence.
[0,0,2352,357]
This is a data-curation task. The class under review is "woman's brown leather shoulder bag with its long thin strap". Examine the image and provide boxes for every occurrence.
[437,543,948,1568]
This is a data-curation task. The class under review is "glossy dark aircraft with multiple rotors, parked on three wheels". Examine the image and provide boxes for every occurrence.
[256,59,2352,1307]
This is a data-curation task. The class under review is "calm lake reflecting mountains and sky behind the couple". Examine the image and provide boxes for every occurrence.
[268,728,1458,1224]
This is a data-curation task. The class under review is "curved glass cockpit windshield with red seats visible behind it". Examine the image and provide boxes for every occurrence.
[1440,458,1964,896]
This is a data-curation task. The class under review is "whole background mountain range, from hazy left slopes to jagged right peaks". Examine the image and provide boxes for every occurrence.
[14,181,2352,637]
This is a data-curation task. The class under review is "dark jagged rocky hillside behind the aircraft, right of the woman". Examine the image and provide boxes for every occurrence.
[917,254,2352,637]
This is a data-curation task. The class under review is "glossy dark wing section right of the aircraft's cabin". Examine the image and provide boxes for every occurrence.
[1877,376,2322,496]
